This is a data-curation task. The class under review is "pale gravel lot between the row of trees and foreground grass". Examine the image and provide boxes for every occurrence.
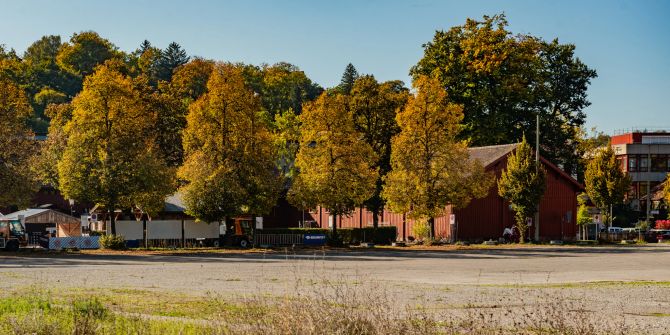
[0,245,670,334]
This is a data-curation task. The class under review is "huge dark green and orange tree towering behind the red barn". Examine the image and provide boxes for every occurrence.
[410,15,596,180]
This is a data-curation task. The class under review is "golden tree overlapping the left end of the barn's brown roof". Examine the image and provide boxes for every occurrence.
[383,77,492,238]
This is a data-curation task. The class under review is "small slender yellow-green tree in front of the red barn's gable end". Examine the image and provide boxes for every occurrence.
[498,136,547,243]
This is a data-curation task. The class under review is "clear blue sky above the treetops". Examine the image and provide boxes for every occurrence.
[0,0,670,133]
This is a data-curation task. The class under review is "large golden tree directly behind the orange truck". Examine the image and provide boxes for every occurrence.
[179,64,280,222]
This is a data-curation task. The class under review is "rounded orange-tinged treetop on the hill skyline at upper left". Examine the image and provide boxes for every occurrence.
[57,31,117,78]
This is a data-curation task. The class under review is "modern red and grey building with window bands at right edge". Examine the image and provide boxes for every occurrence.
[611,131,670,213]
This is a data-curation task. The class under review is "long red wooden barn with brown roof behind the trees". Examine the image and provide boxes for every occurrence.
[310,144,583,241]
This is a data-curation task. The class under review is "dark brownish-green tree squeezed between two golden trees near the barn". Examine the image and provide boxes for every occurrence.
[349,76,409,228]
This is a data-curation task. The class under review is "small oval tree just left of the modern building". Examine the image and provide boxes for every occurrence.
[584,145,631,225]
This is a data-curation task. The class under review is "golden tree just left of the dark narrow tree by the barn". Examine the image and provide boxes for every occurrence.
[289,93,377,235]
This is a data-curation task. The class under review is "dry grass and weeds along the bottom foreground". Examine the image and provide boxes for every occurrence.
[0,278,644,335]
